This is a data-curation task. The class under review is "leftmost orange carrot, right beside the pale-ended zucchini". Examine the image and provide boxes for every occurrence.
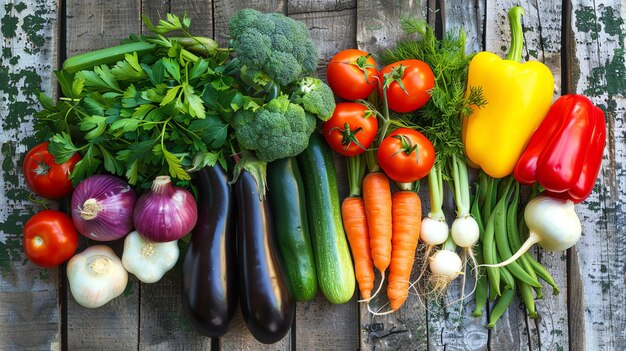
[341,197,374,300]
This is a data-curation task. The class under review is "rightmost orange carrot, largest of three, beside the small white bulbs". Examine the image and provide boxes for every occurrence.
[387,191,422,311]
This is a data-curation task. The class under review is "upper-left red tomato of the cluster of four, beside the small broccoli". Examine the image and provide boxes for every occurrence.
[326,49,378,100]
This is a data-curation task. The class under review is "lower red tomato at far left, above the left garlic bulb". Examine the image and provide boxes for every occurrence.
[24,210,78,268]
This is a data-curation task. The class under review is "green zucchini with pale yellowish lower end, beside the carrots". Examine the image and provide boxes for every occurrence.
[298,133,356,304]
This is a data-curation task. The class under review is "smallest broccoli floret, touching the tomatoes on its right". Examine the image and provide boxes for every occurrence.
[291,77,335,122]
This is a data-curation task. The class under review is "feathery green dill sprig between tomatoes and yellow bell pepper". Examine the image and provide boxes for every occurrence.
[381,18,487,172]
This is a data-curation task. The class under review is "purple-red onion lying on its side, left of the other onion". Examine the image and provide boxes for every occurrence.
[72,175,137,241]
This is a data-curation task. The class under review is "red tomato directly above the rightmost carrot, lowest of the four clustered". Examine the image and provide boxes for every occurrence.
[376,128,435,183]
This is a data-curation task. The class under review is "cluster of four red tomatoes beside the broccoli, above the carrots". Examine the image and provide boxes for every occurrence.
[323,49,435,183]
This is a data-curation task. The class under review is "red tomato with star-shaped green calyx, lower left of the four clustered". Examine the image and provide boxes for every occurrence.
[324,102,378,156]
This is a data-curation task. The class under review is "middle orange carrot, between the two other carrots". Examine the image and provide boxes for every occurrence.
[362,172,391,276]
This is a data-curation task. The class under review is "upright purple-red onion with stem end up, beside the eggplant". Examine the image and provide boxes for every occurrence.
[133,176,198,242]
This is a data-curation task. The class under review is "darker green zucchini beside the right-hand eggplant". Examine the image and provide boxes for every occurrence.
[267,157,317,301]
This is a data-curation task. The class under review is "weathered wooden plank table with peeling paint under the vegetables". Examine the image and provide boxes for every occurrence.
[0,0,626,350]
